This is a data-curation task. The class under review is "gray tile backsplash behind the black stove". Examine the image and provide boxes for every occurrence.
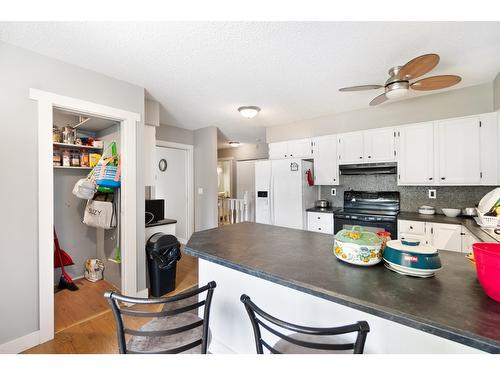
[320,175,495,213]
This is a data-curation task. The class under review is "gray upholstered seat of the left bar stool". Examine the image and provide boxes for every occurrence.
[127,313,210,354]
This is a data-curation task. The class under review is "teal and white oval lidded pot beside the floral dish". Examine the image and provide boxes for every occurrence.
[384,240,442,277]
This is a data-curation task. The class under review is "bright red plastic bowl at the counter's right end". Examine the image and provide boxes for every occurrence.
[472,242,500,302]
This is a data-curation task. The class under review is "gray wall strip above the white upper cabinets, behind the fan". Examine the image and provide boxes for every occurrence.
[266,83,493,143]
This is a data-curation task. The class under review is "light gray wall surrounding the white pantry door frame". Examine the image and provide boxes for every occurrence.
[0,42,145,343]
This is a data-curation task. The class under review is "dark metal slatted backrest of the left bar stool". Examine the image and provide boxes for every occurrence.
[104,281,217,354]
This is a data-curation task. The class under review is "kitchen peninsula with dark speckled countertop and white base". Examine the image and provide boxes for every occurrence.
[185,223,500,353]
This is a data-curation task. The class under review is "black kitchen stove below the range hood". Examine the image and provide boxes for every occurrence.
[334,190,400,238]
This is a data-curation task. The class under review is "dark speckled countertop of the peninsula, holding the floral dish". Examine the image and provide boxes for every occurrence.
[184,223,500,353]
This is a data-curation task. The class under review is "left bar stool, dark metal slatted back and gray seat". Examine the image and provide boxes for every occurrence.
[104,281,216,354]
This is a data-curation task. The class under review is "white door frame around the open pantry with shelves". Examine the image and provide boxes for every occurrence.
[29,88,142,344]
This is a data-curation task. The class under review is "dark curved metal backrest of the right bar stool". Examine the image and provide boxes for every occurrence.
[240,294,370,354]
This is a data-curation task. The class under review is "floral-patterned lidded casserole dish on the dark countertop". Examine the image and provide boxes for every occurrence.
[333,226,382,266]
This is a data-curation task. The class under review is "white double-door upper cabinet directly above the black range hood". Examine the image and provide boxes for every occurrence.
[338,128,396,164]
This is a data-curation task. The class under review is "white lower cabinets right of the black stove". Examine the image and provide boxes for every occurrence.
[398,220,470,253]
